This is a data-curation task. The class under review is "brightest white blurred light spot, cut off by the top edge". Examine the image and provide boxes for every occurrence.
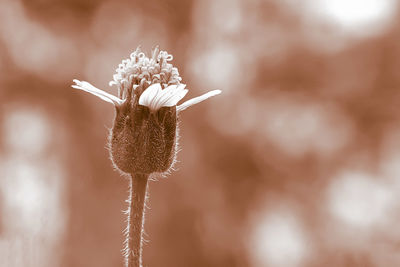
[310,0,397,35]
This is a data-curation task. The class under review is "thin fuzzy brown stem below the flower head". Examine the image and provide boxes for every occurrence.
[125,174,149,267]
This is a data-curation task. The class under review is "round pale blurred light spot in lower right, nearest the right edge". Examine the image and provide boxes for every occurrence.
[327,172,395,231]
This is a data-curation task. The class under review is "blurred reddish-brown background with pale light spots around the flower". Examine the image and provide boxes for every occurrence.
[0,0,400,267]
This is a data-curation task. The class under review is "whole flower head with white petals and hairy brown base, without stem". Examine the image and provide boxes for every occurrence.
[72,47,221,174]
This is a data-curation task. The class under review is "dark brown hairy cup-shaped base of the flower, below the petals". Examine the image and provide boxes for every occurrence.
[110,96,176,174]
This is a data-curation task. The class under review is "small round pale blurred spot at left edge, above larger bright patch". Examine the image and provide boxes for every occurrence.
[2,108,51,155]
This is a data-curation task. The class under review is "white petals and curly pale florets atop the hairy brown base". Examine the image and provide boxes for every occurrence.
[72,47,221,112]
